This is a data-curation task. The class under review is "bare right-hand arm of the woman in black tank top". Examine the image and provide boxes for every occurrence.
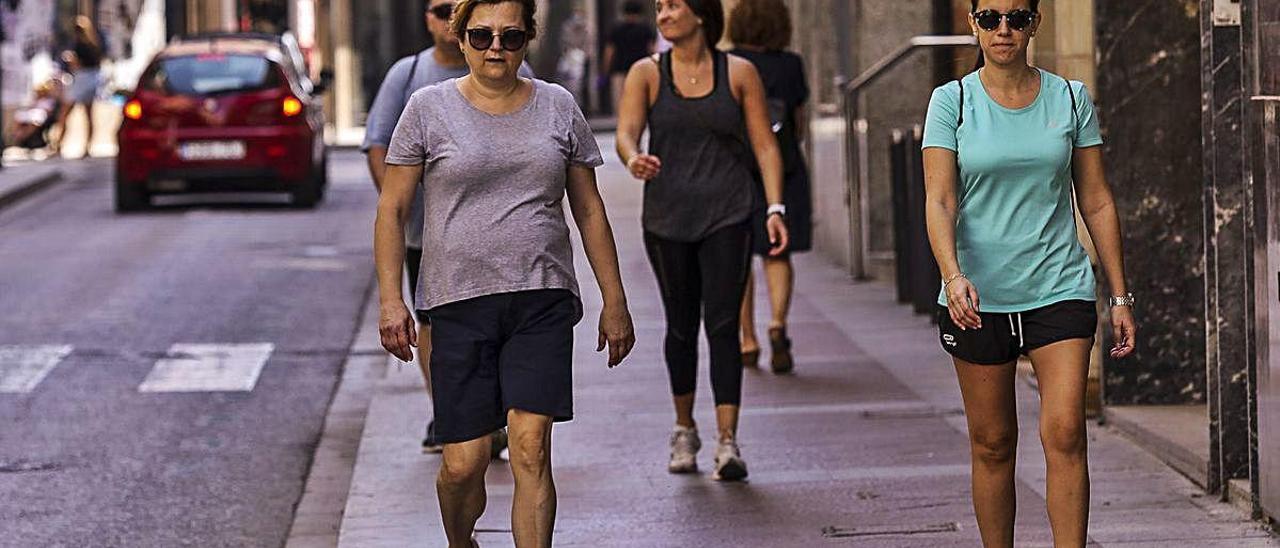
[730,56,788,256]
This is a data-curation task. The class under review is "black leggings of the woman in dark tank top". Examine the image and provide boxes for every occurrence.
[644,223,751,405]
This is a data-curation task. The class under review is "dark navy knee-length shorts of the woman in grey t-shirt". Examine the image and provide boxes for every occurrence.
[428,289,582,443]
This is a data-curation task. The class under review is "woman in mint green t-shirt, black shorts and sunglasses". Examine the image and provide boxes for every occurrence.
[923,0,1135,547]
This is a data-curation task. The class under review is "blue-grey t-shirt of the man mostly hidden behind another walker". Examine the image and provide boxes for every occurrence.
[361,47,534,248]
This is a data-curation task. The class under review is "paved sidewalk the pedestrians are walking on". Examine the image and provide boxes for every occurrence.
[327,138,1280,548]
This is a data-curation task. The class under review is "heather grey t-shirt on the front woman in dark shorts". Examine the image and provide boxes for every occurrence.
[387,79,604,310]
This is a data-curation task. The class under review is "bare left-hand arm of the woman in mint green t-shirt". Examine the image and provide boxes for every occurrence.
[924,147,982,329]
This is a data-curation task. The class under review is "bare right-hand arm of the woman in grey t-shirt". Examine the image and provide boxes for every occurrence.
[567,165,635,367]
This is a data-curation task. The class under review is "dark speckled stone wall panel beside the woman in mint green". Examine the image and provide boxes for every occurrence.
[1094,0,1206,405]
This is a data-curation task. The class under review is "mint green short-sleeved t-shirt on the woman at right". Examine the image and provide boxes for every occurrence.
[922,70,1102,314]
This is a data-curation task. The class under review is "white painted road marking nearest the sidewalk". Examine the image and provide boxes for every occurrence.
[138,343,275,392]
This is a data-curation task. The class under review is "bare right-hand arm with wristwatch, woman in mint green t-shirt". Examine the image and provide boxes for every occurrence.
[1071,146,1135,357]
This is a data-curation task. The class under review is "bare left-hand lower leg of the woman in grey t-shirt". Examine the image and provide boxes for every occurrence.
[435,435,489,548]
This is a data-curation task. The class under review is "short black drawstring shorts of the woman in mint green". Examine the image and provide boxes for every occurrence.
[938,301,1098,365]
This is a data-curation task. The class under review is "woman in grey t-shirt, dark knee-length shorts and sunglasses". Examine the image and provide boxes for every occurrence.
[374,0,635,545]
